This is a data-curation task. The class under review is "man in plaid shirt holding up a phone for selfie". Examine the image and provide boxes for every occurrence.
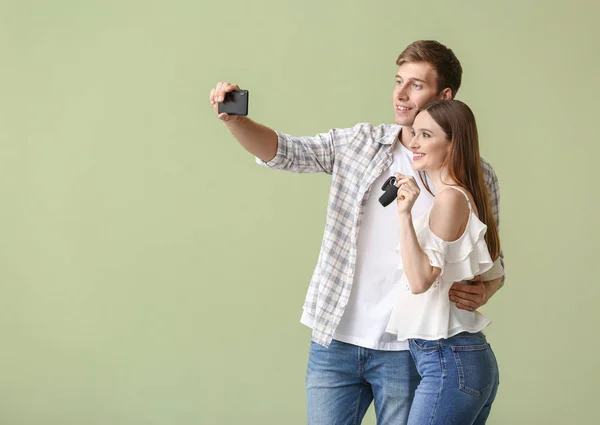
[210,40,504,425]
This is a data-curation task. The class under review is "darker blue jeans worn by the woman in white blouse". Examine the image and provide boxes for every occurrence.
[408,332,499,425]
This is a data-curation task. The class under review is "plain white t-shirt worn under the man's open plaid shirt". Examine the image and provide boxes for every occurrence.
[301,139,433,350]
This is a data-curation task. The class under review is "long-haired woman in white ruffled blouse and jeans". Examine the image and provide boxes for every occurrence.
[387,100,502,425]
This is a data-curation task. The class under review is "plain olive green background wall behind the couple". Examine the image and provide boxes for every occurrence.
[0,0,600,425]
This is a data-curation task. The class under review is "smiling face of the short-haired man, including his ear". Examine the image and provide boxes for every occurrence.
[393,62,451,127]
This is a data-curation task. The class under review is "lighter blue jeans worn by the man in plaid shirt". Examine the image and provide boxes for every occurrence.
[306,340,420,425]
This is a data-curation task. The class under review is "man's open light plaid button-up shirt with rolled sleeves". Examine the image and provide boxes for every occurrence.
[256,123,504,347]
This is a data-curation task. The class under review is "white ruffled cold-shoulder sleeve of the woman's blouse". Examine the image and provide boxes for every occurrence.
[400,213,493,282]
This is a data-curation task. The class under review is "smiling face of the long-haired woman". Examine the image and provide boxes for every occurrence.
[408,111,452,171]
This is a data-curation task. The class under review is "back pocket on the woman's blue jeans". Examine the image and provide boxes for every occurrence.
[451,343,496,397]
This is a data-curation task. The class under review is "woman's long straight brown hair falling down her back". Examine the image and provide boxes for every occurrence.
[419,100,500,261]
